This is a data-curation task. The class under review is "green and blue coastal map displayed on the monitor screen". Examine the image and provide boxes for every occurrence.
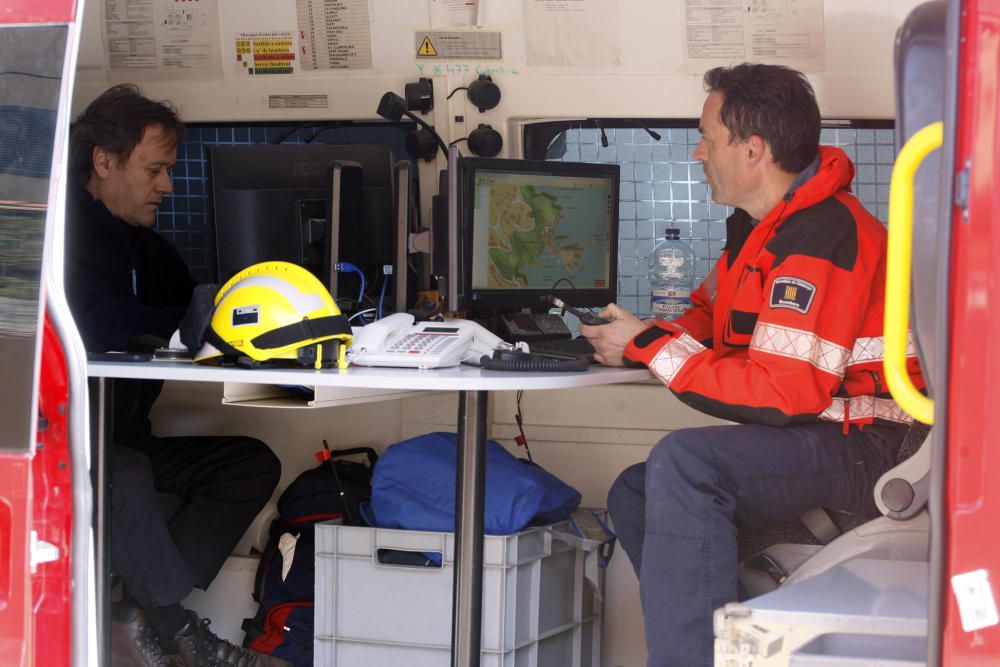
[472,171,612,289]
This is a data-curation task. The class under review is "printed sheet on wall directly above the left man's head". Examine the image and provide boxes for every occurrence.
[101,0,222,81]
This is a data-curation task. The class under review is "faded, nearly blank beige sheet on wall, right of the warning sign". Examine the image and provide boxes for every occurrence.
[523,0,622,66]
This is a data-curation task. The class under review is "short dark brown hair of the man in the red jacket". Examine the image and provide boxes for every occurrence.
[705,63,820,174]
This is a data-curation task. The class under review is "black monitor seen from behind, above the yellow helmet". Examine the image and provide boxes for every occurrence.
[209,144,396,310]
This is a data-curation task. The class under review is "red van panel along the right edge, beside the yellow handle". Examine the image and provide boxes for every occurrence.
[942,0,1000,667]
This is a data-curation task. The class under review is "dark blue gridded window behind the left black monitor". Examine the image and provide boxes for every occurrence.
[156,122,410,282]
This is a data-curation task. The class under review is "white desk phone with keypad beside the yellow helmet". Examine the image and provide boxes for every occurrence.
[347,313,521,368]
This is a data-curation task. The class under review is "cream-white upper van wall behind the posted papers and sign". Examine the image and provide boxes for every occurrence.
[74,0,920,227]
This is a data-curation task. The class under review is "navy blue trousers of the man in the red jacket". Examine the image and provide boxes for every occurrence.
[608,423,898,667]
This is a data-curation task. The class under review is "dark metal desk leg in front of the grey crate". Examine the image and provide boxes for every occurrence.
[451,391,489,667]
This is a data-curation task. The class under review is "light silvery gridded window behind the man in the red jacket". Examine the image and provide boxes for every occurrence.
[524,118,895,315]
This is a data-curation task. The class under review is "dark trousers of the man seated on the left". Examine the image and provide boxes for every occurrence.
[111,436,281,607]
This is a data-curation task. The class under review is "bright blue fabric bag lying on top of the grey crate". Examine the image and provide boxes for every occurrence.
[369,432,581,535]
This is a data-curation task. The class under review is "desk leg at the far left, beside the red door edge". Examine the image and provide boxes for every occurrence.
[90,378,114,665]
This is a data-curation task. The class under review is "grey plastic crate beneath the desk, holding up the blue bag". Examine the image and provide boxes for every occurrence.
[314,524,603,667]
